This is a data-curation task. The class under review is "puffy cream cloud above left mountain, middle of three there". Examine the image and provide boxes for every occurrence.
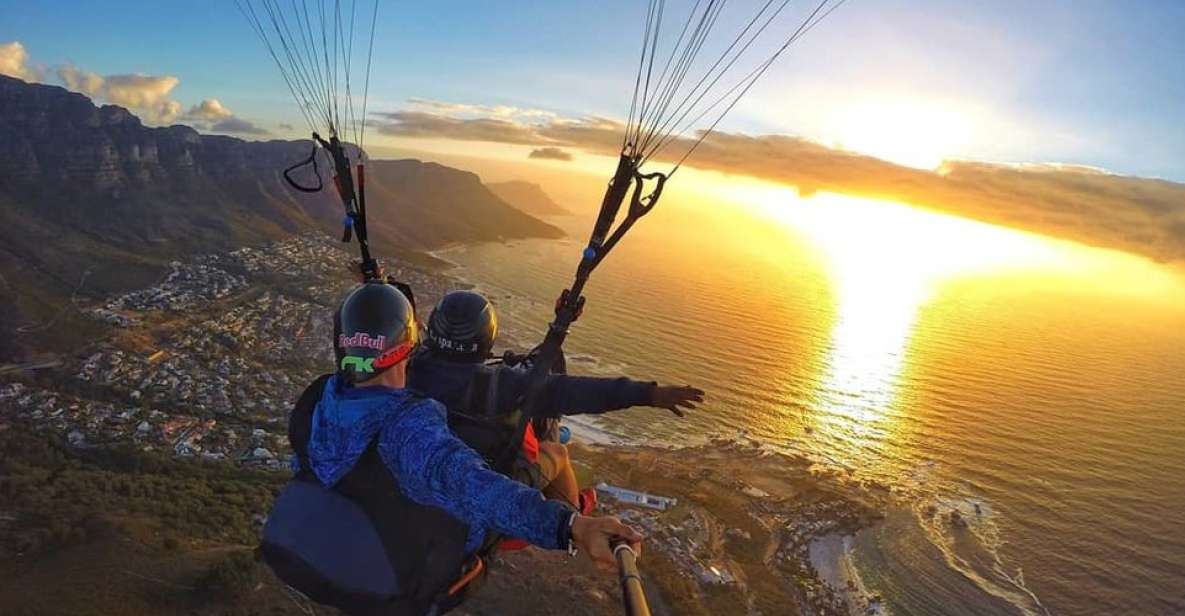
[57,64,181,124]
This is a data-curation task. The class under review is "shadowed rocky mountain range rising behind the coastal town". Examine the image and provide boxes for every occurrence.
[0,76,562,357]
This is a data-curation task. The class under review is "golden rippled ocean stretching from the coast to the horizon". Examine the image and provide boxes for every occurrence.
[441,182,1185,615]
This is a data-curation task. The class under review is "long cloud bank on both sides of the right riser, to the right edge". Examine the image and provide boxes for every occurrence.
[376,102,1185,261]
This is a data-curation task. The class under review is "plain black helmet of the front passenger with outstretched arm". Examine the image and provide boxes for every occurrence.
[424,291,498,361]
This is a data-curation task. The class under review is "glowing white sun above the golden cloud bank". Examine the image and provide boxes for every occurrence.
[824,97,974,171]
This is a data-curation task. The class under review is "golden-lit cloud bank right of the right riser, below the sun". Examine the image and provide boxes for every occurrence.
[658,133,1185,261]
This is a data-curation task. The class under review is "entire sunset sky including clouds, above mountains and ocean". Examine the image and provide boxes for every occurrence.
[0,0,1185,259]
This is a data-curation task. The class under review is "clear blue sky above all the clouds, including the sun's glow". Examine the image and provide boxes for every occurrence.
[0,0,1185,180]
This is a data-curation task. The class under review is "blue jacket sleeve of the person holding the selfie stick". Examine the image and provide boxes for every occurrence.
[379,400,572,550]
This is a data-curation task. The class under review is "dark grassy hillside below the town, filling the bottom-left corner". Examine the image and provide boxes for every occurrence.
[0,423,292,615]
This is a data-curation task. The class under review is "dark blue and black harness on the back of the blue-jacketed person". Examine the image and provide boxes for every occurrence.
[260,374,486,616]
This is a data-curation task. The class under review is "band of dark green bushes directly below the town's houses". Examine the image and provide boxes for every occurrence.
[0,424,287,554]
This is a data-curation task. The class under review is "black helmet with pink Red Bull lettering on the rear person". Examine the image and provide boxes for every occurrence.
[333,281,419,384]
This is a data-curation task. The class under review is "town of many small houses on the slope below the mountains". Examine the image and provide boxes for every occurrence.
[0,237,443,469]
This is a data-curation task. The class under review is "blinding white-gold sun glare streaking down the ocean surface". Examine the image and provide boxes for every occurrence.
[720,184,1181,471]
